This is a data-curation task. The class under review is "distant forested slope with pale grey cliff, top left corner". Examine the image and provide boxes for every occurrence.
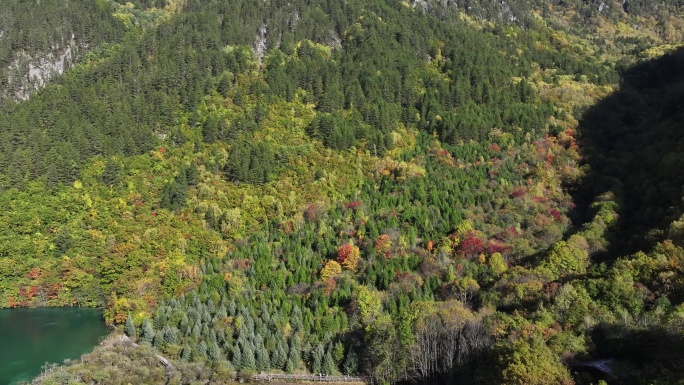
[0,0,125,100]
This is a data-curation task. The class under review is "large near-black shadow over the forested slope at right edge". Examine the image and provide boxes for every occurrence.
[575,48,684,260]
